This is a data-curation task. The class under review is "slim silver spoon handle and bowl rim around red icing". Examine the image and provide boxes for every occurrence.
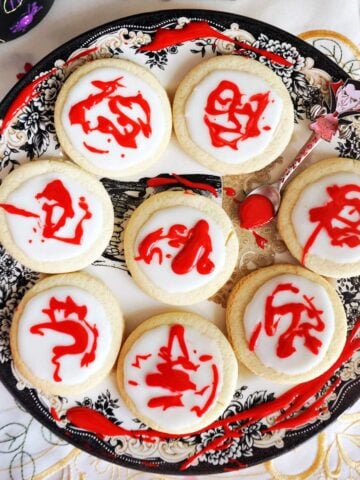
[239,132,322,228]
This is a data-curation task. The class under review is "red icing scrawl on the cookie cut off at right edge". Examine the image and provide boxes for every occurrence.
[301,184,360,264]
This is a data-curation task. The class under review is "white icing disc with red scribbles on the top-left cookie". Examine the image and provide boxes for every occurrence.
[61,67,165,170]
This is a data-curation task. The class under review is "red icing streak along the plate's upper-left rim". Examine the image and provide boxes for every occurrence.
[0,47,97,135]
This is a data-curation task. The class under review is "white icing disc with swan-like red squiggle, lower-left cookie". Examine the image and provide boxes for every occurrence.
[17,286,111,385]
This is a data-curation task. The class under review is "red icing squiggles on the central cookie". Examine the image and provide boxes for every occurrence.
[135,220,215,275]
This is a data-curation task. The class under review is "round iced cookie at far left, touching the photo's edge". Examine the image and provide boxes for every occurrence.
[0,160,114,273]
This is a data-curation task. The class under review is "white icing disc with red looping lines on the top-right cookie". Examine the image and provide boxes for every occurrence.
[185,70,283,164]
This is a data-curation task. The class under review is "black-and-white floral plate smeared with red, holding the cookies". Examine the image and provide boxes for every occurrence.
[0,10,360,475]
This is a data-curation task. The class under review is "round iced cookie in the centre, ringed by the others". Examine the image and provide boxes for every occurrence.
[124,191,238,305]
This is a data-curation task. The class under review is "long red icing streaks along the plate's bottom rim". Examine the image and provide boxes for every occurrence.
[66,319,360,470]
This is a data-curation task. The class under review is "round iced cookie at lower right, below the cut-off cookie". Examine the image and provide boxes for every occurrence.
[226,264,347,384]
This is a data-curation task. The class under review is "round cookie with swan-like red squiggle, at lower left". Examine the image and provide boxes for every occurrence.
[10,272,124,395]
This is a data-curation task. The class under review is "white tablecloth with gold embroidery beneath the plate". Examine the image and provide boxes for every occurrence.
[0,0,360,480]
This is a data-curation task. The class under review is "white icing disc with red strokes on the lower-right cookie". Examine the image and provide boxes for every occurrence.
[243,274,335,375]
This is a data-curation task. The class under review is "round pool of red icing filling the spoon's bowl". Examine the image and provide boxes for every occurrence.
[239,193,275,230]
